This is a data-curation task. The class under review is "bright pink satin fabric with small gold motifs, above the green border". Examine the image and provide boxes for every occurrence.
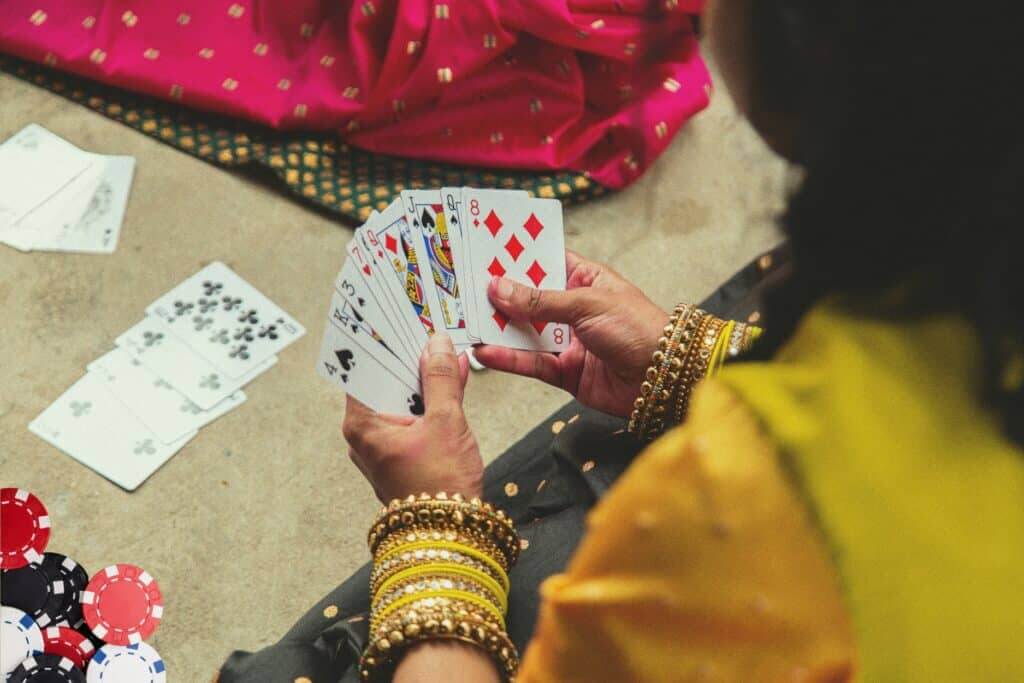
[0,0,711,187]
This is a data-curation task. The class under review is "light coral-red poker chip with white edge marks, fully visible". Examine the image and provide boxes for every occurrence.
[82,564,164,645]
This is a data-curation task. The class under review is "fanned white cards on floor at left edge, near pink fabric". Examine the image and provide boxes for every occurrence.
[0,124,135,254]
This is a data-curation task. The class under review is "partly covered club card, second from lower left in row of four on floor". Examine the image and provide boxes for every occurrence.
[88,348,246,443]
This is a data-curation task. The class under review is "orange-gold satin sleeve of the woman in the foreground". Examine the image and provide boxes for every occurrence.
[517,380,854,683]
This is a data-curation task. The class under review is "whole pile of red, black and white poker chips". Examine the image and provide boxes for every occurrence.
[0,488,167,683]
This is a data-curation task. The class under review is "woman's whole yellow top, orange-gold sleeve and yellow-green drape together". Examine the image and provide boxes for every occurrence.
[519,306,1024,683]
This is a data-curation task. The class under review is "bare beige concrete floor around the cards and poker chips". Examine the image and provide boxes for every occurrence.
[0,60,785,682]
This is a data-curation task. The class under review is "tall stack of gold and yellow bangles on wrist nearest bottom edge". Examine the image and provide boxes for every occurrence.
[359,494,519,681]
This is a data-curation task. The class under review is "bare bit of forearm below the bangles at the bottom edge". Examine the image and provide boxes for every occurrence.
[394,640,501,683]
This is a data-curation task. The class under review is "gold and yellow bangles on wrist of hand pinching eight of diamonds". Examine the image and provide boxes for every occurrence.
[628,304,761,441]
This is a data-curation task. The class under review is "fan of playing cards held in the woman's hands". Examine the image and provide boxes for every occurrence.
[316,187,569,415]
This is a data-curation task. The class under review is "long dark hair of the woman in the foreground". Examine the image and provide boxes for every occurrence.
[751,0,1024,443]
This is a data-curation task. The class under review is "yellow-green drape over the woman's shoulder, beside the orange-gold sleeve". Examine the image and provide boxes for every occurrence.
[719,304,1024,683]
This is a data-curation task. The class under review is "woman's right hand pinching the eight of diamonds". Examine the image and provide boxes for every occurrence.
[475,251,669,417]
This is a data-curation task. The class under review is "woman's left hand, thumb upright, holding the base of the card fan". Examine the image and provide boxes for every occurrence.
[342,333,483,503]
